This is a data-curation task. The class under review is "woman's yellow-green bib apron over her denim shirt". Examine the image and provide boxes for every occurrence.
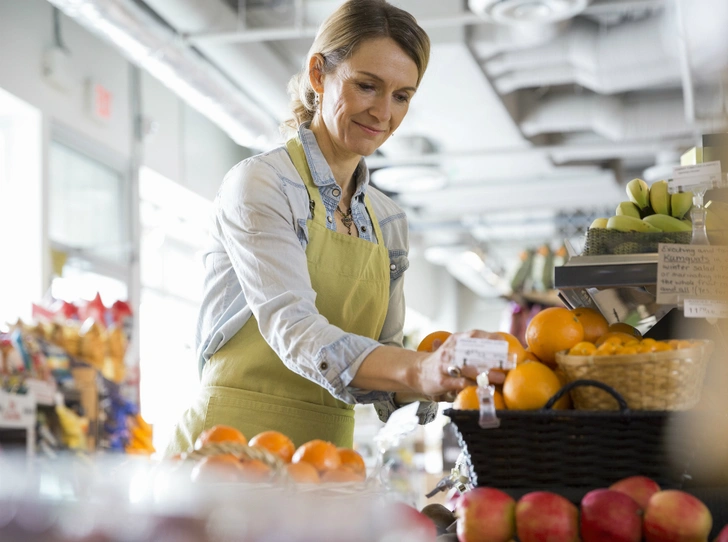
[166,138,389,455]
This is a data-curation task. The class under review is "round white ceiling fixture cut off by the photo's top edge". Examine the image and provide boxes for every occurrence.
[468,0,589,25]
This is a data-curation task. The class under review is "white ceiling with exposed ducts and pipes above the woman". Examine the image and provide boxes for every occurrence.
[52,0,728,295]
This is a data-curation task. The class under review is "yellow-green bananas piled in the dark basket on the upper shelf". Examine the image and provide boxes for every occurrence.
[590,179,693,233]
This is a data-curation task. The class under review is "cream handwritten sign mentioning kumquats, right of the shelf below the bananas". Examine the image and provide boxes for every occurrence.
[657,243,728,305]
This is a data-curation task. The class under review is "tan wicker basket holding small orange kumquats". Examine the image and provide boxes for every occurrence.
[556,341,713,410]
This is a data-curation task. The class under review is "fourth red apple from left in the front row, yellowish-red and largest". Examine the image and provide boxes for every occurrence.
[642,489,713,542]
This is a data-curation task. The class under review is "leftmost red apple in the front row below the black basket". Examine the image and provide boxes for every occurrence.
[455,487,516,542]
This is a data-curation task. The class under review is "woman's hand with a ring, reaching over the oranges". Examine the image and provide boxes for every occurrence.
[410,329,505,401]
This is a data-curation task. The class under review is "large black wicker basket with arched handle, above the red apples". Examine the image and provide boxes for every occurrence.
[444,380,694,490]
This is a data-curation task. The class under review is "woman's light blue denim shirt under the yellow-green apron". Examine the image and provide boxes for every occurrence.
[195,124,437,423]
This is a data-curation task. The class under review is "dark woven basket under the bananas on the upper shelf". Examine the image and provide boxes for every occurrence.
[582,228,693,256]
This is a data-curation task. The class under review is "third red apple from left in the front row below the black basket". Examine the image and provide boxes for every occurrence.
[581,489,642,542]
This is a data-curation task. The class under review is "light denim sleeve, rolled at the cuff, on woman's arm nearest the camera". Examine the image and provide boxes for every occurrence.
[215,159,391,404]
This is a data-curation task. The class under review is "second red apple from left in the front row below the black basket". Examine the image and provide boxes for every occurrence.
[516,491,579,542]
